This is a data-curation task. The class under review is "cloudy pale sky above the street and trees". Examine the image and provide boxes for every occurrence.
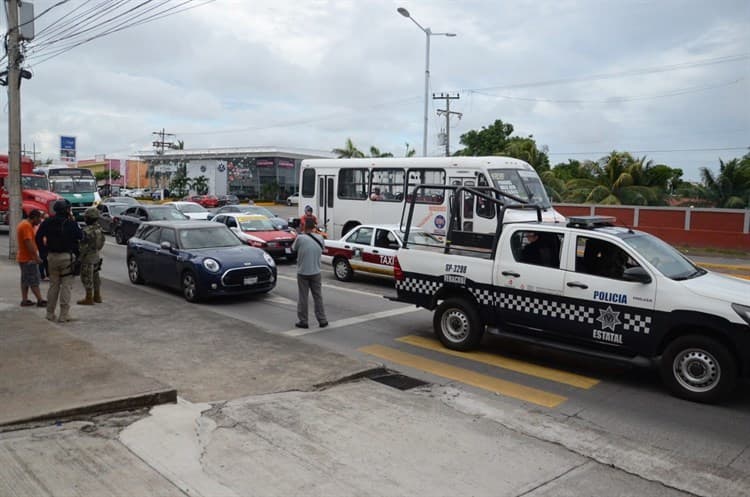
[0,0,750,179]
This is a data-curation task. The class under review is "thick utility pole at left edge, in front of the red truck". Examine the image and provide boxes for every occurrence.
[7,0,22,260]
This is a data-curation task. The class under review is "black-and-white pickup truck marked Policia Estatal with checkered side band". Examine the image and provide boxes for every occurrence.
[393,187,750,402]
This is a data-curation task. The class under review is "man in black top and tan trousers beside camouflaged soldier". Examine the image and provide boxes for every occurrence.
[36,200,83,323]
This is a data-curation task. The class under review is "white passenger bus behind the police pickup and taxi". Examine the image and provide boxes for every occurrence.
[299,156,565,238]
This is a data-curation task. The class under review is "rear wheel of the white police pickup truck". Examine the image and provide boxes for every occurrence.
[432,298,484,350]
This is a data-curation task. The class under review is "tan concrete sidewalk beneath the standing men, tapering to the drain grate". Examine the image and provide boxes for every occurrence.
[0,260,379,426]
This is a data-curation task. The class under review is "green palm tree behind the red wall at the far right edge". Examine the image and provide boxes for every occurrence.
[700,154,750,209]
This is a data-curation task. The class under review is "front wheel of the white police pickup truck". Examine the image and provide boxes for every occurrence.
[661,335,737,403]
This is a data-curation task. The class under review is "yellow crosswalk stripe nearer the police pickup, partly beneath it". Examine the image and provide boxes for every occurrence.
[396,335,599,390]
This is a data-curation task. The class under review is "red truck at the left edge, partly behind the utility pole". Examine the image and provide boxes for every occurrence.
[0,155,61,225]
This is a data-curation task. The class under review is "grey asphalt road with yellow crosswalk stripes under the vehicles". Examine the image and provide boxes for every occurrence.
[0,207,750,474]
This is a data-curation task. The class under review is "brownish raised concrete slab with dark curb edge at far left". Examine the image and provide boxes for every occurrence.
[0,261,177,426]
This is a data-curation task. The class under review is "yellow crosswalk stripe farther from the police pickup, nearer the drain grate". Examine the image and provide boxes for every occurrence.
[357,345,568,407]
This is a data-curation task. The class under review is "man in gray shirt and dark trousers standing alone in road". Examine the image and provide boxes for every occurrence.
[292,218,328,328]
